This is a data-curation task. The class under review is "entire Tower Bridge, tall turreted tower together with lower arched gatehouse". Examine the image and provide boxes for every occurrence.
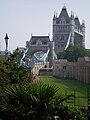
[21,6,85,77]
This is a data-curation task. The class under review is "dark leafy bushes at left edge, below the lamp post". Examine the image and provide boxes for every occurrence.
[0,52,29,102]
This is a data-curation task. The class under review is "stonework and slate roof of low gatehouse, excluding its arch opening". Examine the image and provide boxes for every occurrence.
[26,36,56,68]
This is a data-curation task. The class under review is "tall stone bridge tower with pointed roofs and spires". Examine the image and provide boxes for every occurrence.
[53,6,85,53]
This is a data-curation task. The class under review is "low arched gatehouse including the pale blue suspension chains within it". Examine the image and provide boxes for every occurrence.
[21,36,57,68]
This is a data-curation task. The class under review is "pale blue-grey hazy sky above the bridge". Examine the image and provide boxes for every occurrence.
[0,0,90,51]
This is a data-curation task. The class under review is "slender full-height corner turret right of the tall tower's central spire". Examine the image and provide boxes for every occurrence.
[70,12,75,45]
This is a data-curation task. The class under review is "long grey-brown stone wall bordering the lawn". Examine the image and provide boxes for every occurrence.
[53,57,90,83]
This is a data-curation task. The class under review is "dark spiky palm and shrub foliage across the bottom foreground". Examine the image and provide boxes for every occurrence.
[0,82,82,120]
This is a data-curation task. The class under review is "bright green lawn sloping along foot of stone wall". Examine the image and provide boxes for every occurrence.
[40,76,90,106]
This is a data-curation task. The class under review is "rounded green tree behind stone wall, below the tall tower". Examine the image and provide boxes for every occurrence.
[58,45,90,62]
